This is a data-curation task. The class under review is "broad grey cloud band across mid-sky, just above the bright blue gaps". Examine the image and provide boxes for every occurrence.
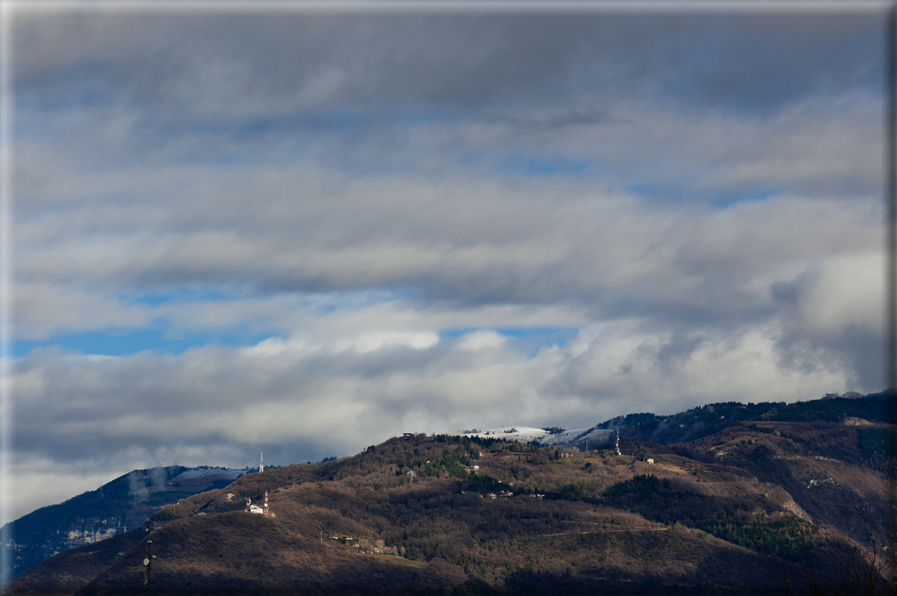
[17,162,880,333]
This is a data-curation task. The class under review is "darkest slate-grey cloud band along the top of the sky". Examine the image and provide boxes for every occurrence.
[16,12,883,118]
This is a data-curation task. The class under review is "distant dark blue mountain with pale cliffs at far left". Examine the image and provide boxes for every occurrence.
[0,466,244,578]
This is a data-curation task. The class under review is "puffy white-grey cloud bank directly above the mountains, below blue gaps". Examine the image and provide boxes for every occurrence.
[8,312,849,512]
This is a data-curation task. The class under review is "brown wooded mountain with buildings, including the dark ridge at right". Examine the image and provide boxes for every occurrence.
[5,394,894,596]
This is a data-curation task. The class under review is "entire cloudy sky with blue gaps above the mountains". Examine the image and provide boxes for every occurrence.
[0,7,884,521]
